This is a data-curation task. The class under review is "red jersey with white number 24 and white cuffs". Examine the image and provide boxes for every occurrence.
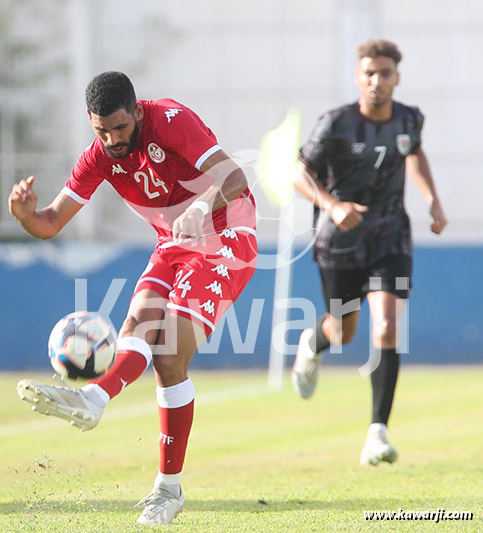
[63,98,255,241]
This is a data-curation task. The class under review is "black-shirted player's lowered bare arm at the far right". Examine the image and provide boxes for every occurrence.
[406,147,448,235]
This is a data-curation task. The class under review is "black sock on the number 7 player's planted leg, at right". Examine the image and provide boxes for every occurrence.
[371,348,399,425]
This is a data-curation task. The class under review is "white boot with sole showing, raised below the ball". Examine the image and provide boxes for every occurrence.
[17,379,103,431]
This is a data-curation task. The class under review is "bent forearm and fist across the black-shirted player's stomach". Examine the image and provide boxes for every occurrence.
[294,161,368,231]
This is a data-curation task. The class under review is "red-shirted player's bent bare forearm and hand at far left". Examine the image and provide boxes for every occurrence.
[8,176,82,239]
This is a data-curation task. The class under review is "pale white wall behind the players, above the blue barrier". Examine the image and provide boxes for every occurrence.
[0,0,483,244]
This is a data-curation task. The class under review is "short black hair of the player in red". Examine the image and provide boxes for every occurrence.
[86,71,136,117]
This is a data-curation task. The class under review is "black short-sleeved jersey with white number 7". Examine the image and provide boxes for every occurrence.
[299,102,424,268]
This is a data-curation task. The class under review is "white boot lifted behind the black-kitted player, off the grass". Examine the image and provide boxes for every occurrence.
[292,328,322,398]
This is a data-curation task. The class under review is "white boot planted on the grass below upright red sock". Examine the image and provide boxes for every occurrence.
[134,485,184,524]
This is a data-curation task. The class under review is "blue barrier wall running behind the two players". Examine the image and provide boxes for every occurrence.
[0,242,483,370]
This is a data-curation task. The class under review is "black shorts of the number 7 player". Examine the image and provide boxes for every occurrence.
[319,254,412,312]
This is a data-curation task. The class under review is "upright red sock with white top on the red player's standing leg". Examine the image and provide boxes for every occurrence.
[156,378,195,481]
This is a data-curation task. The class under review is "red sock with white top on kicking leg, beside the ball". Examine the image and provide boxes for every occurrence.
[89,337,152,398]
